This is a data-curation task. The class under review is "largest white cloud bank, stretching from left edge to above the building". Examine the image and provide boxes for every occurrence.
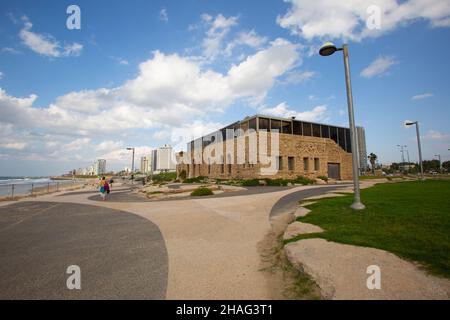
[0,39,299,160]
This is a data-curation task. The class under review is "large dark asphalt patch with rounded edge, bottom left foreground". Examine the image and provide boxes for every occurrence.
[0,202,168,299]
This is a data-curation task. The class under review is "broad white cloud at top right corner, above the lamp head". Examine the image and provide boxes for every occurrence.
[277,0,450,41]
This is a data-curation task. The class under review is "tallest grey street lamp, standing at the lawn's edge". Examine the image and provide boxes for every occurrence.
[319,42,365,210]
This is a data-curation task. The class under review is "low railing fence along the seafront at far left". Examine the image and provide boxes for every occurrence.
[0,180,84,199]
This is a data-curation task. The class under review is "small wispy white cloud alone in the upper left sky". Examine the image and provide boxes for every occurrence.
[19,16,83,58]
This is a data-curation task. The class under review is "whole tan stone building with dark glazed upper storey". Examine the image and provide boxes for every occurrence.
[177,115,352,180]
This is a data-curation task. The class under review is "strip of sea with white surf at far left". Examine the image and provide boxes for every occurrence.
[0,177,73,196]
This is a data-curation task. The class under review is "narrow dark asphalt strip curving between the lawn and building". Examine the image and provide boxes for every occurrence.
[270,185,348,217]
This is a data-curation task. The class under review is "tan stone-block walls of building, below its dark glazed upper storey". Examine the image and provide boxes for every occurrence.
[177,133,352,180]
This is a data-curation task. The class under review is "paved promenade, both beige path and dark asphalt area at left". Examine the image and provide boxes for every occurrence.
[0,186,334,299]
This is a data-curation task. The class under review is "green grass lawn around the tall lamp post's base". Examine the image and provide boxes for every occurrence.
[287,180,450,278]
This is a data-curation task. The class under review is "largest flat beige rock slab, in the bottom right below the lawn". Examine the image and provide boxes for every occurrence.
[285,239,450,300]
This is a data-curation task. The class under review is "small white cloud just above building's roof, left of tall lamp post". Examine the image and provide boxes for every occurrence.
[259,102,328,121]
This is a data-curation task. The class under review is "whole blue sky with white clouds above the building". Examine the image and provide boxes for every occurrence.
[0,0,450,176]
